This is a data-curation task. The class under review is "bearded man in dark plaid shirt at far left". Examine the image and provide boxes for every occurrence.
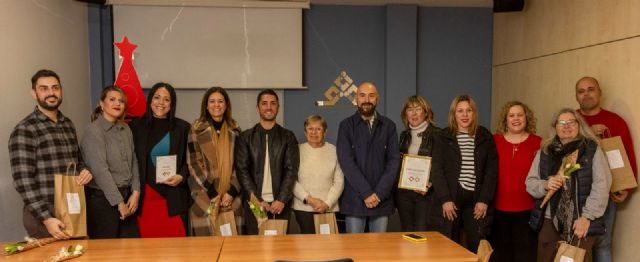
[9,69,92,239]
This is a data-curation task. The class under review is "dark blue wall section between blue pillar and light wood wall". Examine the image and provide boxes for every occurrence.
[418,7,493,127]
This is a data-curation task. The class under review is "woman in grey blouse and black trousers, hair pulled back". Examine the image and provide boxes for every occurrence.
[80,86,140,239]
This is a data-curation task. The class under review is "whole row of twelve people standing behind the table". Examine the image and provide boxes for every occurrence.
[9,70,636,261]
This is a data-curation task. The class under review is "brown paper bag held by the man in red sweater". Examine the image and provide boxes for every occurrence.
[600,136,638,192]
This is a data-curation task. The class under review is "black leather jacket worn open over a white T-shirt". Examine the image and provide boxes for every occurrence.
[234,123,300,203]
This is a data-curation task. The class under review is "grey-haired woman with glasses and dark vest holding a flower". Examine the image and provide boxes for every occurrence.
[526,108,611,262]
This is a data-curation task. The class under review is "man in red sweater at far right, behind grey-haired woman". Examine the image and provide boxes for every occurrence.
[576,76,638,262]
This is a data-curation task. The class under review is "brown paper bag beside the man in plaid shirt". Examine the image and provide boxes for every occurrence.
[54,162,87,238]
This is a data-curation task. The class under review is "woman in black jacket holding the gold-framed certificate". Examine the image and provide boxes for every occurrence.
[396,95,441,232]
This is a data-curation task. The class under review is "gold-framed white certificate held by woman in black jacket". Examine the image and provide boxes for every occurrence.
[398,154,431,191]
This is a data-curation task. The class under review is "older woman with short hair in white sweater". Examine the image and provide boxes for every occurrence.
[293,115,344,234]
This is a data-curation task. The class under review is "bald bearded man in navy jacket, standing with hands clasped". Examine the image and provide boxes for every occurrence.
[336,82,400,233]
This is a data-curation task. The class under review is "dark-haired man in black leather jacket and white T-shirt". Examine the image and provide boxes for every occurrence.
[234,89,300,235]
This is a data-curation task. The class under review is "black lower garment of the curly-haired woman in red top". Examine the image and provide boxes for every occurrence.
[489,210,538,262]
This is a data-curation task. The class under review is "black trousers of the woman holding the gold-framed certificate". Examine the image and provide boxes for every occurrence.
[396,189,432,232]
